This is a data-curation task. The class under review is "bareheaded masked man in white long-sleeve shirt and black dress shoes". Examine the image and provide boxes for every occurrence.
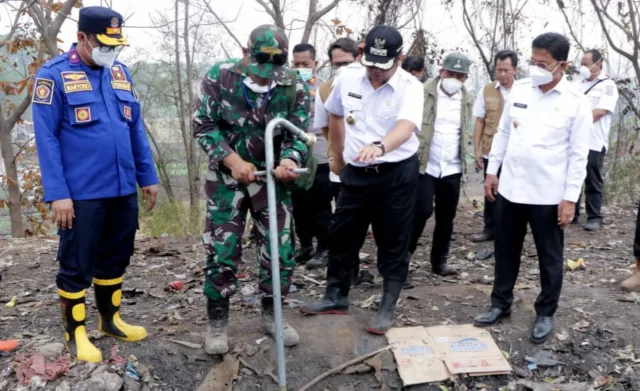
[474,33,593,343]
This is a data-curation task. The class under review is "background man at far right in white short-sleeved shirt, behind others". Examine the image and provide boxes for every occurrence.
[572,49,618,231]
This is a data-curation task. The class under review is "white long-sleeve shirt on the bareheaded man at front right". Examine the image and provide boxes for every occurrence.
[487,77,593,205]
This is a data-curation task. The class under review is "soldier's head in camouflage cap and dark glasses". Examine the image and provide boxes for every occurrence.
[247,24,289,81]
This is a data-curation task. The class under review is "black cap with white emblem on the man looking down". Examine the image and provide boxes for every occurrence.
[361,25,402,70]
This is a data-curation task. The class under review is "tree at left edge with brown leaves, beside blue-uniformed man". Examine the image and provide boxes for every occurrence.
[0,0,80,237]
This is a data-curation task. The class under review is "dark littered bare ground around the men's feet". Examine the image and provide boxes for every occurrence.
[0,202,640,391]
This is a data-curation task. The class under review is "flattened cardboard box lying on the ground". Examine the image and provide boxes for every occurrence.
[387,324,511,386]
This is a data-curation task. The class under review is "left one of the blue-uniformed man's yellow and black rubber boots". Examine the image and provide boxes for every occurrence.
[58,289,102,363]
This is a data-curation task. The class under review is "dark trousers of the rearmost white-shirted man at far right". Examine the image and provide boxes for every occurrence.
[575,148,607,221]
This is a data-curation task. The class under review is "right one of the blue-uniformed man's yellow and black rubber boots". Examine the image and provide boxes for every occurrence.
[93,277,147,342]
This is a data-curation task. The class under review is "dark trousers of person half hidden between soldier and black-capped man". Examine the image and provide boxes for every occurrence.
[291,163,340,250]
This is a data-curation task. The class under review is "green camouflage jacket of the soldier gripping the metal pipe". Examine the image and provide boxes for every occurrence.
[193,59,311,174]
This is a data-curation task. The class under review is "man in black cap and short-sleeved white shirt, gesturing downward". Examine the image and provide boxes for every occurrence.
[301,25,423,334]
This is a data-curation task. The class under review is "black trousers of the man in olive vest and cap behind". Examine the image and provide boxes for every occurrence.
[409,174,462,267]
